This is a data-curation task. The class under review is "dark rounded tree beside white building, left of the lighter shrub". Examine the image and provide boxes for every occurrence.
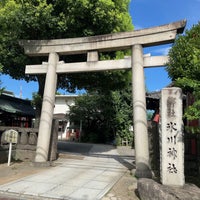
[69,93,113,142]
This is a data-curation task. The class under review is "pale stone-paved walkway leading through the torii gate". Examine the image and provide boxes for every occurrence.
[0,145,134,200]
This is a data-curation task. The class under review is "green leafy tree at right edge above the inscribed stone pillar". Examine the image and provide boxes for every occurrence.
[167,22,200,120]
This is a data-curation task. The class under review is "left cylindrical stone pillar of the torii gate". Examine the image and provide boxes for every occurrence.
[35,53,59,163]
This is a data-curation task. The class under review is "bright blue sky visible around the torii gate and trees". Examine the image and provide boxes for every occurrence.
[0,0,200,99]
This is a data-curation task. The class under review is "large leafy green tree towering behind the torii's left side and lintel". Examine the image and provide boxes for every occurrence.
[0,0,133,126]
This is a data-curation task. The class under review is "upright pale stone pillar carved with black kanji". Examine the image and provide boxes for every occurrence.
[160,87,185,186]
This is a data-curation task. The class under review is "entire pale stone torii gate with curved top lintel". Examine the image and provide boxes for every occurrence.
[20,20,186,177]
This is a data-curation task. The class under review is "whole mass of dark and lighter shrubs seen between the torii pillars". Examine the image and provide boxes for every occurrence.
[69,85,133,143]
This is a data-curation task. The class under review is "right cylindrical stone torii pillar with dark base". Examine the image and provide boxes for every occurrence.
[131,44,152,178]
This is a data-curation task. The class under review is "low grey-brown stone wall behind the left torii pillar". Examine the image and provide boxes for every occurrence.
[0,120,58,163]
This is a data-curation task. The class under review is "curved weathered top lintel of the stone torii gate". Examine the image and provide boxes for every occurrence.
[20,20,186,56]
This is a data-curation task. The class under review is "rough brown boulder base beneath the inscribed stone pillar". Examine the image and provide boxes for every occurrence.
[137,178,200,200]
